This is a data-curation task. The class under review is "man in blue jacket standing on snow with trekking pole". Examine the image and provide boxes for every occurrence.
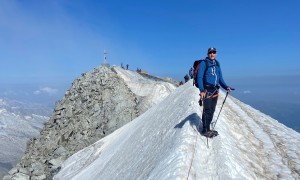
[197,48,233,137]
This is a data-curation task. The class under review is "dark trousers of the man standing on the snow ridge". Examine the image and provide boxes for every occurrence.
[202,88,218,132]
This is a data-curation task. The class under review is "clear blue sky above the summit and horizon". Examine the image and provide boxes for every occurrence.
[0,0,300,102]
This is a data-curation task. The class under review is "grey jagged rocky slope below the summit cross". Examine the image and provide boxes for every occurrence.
[4,67,176,179]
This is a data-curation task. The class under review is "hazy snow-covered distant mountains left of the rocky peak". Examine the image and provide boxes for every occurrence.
[0,99,51,178]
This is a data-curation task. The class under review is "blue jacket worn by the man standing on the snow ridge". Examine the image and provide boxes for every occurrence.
[197,57,228,92]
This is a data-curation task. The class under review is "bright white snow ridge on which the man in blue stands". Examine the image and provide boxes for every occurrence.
[54,81,300,180]
